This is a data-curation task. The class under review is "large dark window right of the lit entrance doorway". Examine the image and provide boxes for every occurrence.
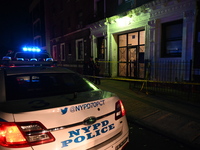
[161,20,183,57]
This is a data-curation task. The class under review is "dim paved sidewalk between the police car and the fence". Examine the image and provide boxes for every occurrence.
[98,79,200,149]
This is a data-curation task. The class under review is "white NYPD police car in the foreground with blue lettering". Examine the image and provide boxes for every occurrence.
[0,52,129,150]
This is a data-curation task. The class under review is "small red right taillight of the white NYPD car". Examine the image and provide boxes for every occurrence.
[115,100,126,120]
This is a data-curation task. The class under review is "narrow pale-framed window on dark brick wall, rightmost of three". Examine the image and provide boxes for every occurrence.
[76,39,84,61]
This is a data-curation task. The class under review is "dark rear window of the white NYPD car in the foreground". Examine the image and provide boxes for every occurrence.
[6,73,94,100]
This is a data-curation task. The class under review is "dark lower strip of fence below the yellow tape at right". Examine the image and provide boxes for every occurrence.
[130,81,200,104]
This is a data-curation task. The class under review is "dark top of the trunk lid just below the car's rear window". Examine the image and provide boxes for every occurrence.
[0,90,116,113]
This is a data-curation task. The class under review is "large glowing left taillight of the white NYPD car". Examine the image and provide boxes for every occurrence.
[0,121,55,148]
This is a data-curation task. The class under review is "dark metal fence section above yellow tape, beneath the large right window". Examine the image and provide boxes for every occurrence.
[146,60,193,82]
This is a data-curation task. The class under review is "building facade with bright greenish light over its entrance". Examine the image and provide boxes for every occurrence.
[29,0,200,81]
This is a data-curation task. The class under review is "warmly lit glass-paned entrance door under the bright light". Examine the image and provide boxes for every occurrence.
[118,30,145,78]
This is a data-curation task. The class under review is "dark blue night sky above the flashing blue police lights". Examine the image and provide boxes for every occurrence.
[0,0,32,56]
